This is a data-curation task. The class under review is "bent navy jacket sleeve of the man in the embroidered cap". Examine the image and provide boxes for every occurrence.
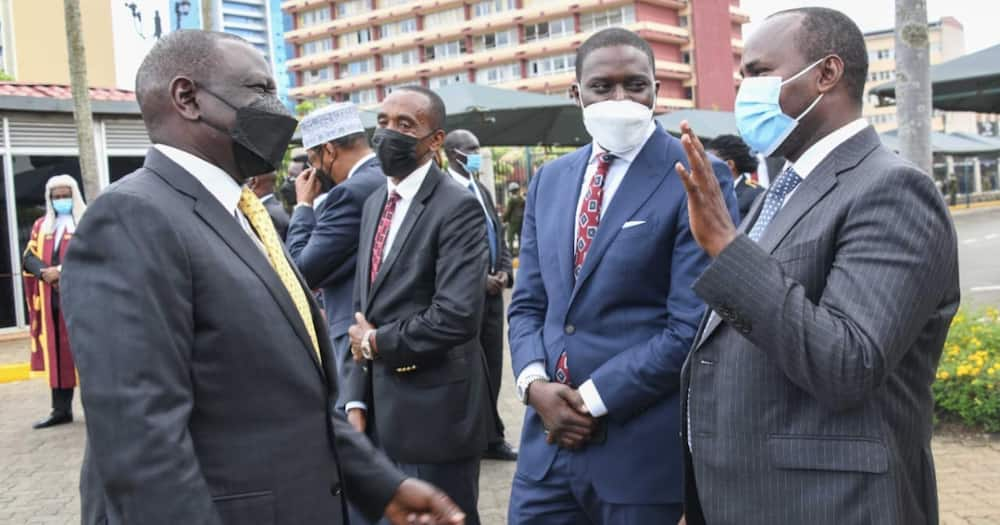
[288,187,364,289]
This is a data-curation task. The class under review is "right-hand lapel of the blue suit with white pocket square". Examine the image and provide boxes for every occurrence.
[570,126,678,302]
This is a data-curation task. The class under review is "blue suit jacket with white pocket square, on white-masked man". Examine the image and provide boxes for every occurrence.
[509,125,738,504]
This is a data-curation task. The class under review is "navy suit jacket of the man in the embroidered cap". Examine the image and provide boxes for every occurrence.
[287,158,386,337]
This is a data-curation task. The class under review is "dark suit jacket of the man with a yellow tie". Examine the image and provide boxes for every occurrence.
[62,149,403,525]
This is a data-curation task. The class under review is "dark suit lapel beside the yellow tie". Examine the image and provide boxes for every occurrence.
[146,149,323,373]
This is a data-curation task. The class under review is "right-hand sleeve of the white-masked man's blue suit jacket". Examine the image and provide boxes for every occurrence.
[590,157,739,422]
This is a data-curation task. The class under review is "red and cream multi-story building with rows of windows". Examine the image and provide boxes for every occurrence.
[281,0,749,112]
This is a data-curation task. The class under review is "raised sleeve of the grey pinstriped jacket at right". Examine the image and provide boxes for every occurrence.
[695,167,958,410]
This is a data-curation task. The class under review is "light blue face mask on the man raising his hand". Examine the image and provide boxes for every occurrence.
[734,57,826,157]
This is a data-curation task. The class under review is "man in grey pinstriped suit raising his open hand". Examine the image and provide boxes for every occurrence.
[678,8,959,525]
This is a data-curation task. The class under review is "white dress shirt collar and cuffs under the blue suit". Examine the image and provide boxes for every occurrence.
[517,122,656,417]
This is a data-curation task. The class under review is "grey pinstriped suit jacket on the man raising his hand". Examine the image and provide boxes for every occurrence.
[681,128,959,525]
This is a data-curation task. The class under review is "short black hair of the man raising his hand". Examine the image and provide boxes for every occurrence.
[768,7,868,105]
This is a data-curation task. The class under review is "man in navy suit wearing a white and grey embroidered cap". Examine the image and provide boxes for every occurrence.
[286,102,385,410]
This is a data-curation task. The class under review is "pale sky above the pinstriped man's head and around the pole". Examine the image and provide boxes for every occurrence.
[740,0,1000,53]
